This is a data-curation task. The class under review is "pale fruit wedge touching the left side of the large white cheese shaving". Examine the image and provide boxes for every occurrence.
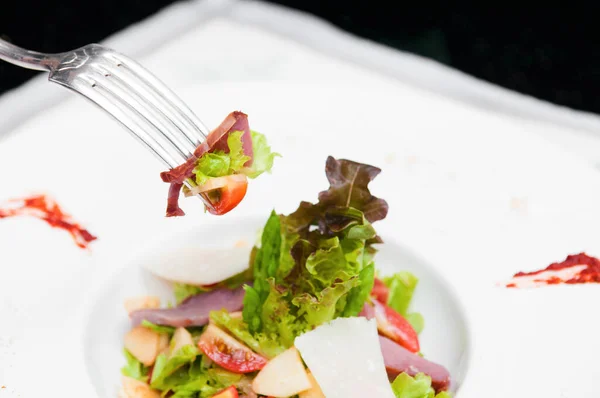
[252,347,312,398]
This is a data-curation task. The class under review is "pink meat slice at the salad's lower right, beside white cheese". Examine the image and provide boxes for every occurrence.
[379,336,450,392]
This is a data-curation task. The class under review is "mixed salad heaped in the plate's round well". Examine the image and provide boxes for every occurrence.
[119,157,451,398]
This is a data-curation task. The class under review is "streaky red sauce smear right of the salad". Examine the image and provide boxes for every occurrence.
[506,253,600,288]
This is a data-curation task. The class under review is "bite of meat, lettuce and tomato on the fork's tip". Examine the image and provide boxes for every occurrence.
[160,111,279,217]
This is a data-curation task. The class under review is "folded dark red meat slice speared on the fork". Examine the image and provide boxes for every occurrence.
[160,111,253,217]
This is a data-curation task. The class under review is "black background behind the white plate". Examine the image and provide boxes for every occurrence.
[0,0,600,113]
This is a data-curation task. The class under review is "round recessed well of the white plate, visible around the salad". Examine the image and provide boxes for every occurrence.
[82,218,470,398]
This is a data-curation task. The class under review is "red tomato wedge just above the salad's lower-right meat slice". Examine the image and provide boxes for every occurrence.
[373,300,420,352]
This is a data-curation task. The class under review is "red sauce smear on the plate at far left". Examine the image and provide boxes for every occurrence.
[0,195,97,249]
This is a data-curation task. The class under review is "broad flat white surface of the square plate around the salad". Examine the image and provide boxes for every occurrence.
[0,10,600,398]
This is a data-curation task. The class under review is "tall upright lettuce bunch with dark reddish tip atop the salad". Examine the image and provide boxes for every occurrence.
[243,157,387,348]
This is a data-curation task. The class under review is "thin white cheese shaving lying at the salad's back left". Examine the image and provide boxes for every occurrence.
[144,246,252,286]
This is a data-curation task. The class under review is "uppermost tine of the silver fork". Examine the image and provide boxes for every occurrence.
[106,52,210,145]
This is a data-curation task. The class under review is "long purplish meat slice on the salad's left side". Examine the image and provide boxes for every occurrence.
[130,287,244,327]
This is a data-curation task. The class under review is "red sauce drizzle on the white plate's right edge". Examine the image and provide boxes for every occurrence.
[506,253,600,288]
